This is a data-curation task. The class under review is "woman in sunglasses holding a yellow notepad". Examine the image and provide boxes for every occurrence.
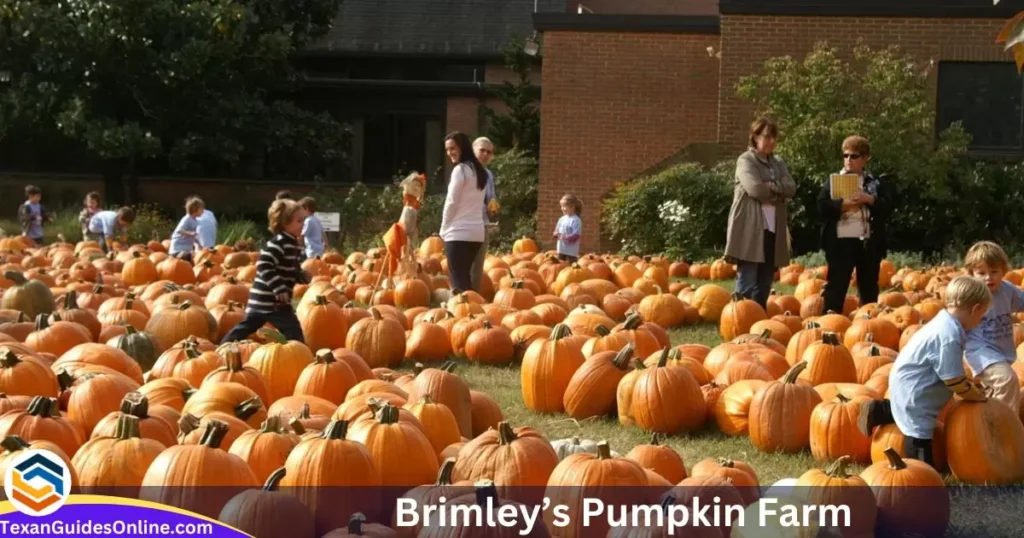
[818,136,891,313]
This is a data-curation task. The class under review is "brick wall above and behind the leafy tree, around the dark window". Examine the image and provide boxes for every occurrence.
[718,15,1011,151]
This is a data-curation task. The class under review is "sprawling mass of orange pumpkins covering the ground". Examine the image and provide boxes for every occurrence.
[0,237,1021,536]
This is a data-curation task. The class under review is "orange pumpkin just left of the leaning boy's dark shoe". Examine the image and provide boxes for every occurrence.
[811,392,871,463]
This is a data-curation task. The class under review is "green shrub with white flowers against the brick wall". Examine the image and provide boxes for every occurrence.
[601,162,735,260]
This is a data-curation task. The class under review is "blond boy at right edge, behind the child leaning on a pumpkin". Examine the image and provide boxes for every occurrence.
[964,241,1024,411]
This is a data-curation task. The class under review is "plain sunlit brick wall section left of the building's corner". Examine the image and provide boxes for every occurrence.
[538,32,719,251]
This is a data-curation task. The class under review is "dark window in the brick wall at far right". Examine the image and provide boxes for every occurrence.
[937,61,1024,152]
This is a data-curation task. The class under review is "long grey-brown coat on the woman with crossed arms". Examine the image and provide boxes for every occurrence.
[725,149,797,267]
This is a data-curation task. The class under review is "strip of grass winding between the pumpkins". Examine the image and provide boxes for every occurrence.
[397,281,1024,536]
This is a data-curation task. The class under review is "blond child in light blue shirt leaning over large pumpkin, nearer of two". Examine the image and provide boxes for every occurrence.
[857,277,992,466]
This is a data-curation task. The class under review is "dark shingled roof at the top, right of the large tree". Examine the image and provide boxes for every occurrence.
[310,0,565,56]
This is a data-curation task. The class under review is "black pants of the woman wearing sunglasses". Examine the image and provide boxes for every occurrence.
[821,239,882,314]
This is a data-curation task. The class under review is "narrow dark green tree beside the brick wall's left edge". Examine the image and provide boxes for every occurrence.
[483,38,541,156]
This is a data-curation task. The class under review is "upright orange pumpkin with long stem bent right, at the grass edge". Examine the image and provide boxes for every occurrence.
[750,362,821,453]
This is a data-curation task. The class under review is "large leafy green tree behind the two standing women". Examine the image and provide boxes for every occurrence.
[737,43,970,253]
